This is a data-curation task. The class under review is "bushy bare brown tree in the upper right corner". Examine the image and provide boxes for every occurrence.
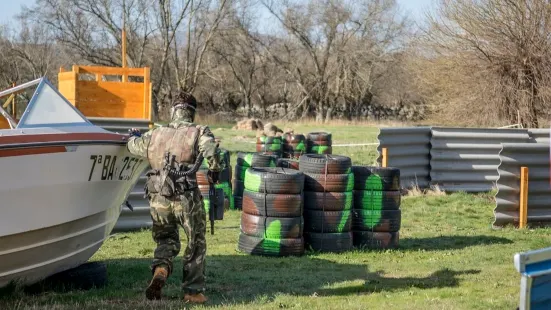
[421,0,551,127]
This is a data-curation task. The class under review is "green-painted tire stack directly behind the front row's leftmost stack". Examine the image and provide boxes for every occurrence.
[232,152,277,210]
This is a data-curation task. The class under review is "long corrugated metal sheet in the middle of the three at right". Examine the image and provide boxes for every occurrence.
[430,127,530,192]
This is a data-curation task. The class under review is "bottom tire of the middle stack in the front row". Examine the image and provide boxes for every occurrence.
[304,232,353,253]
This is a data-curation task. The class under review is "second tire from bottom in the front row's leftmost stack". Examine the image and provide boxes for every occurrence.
[241,212,304,239]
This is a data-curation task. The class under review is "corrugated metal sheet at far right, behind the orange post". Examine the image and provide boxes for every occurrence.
[494,143,551,227]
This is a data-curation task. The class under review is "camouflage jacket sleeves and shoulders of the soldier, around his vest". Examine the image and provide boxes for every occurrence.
[127,120,225,172]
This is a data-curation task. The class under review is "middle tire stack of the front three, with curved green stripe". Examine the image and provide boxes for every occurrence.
[299,154,354,253]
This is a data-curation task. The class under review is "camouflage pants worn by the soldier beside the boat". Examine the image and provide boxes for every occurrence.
[149,189,207,293]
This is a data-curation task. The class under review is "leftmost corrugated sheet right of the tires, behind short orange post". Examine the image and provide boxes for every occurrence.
[377,127,431,188]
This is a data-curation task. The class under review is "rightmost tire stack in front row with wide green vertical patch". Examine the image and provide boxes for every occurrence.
[352,166,402,249]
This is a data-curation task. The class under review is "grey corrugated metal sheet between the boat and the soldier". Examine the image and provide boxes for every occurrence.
[88,117,153,232]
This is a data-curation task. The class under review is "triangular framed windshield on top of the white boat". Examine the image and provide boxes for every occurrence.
[0,78,93,129]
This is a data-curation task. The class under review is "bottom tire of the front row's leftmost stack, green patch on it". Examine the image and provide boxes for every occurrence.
[237,233,304,256]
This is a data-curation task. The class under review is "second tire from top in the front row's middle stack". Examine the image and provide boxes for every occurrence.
[304,173,354,192]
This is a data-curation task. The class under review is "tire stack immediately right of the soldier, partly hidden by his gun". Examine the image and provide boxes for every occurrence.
[196,149,235,212]
